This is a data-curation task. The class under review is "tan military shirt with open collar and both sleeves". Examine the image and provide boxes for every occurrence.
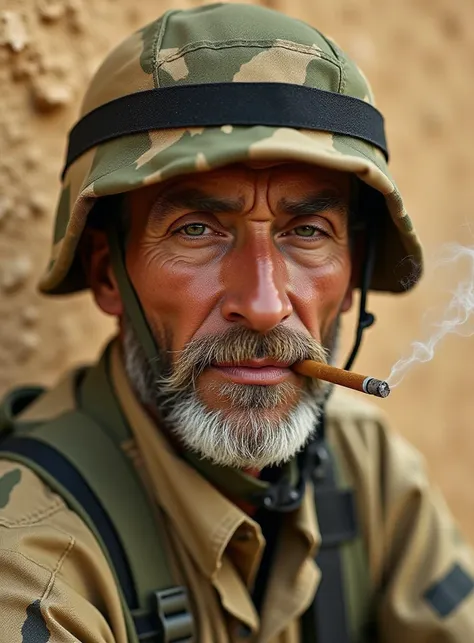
[0,350,474,643]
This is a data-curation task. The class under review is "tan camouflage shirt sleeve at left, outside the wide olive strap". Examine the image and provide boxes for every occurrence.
[0,461,127,643]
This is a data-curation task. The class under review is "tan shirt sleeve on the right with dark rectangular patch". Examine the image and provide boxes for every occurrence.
[378,432,474,643]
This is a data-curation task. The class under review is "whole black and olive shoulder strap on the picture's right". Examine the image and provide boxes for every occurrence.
[302,440,368,643]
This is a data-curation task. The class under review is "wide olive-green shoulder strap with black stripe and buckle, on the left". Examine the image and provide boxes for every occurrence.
[0,390,192,643]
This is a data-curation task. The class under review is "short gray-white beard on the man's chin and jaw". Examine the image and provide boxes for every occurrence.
[123,320,338,470]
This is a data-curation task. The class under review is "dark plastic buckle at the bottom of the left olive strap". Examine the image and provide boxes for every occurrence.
[154,586,195,643]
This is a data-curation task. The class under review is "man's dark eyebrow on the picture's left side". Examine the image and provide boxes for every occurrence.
[152,189,244,224]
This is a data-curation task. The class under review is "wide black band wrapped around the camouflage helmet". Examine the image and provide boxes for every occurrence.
[62,83,388,177]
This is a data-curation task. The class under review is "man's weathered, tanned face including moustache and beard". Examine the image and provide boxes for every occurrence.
[116,164,351,466]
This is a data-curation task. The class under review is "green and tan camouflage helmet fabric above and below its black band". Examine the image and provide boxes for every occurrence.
[40,4,422,294]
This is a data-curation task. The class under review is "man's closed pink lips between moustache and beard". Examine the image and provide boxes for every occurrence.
[211,359,294,386]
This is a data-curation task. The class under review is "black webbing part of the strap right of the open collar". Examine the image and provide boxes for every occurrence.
[302,440,358,643]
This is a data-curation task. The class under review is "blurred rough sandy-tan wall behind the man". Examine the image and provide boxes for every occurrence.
[0,0,474,542]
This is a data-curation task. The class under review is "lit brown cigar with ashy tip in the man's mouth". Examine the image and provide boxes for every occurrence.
[292,359,390,397]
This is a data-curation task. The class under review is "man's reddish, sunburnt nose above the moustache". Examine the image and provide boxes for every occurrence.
[221,238,293,333]
